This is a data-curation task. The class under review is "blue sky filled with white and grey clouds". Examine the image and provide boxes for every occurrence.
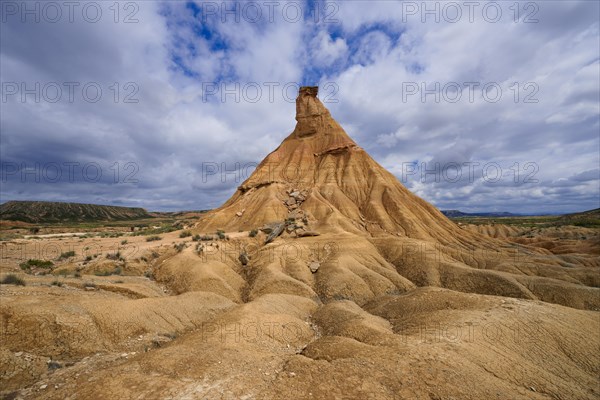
[0,0,600,213]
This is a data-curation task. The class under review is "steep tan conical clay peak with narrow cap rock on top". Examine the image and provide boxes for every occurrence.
[201,88,476,243]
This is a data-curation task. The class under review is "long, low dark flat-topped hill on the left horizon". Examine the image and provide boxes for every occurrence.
[0,201,152,223]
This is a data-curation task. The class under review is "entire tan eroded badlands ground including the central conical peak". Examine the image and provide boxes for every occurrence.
[0,87,600,400]
